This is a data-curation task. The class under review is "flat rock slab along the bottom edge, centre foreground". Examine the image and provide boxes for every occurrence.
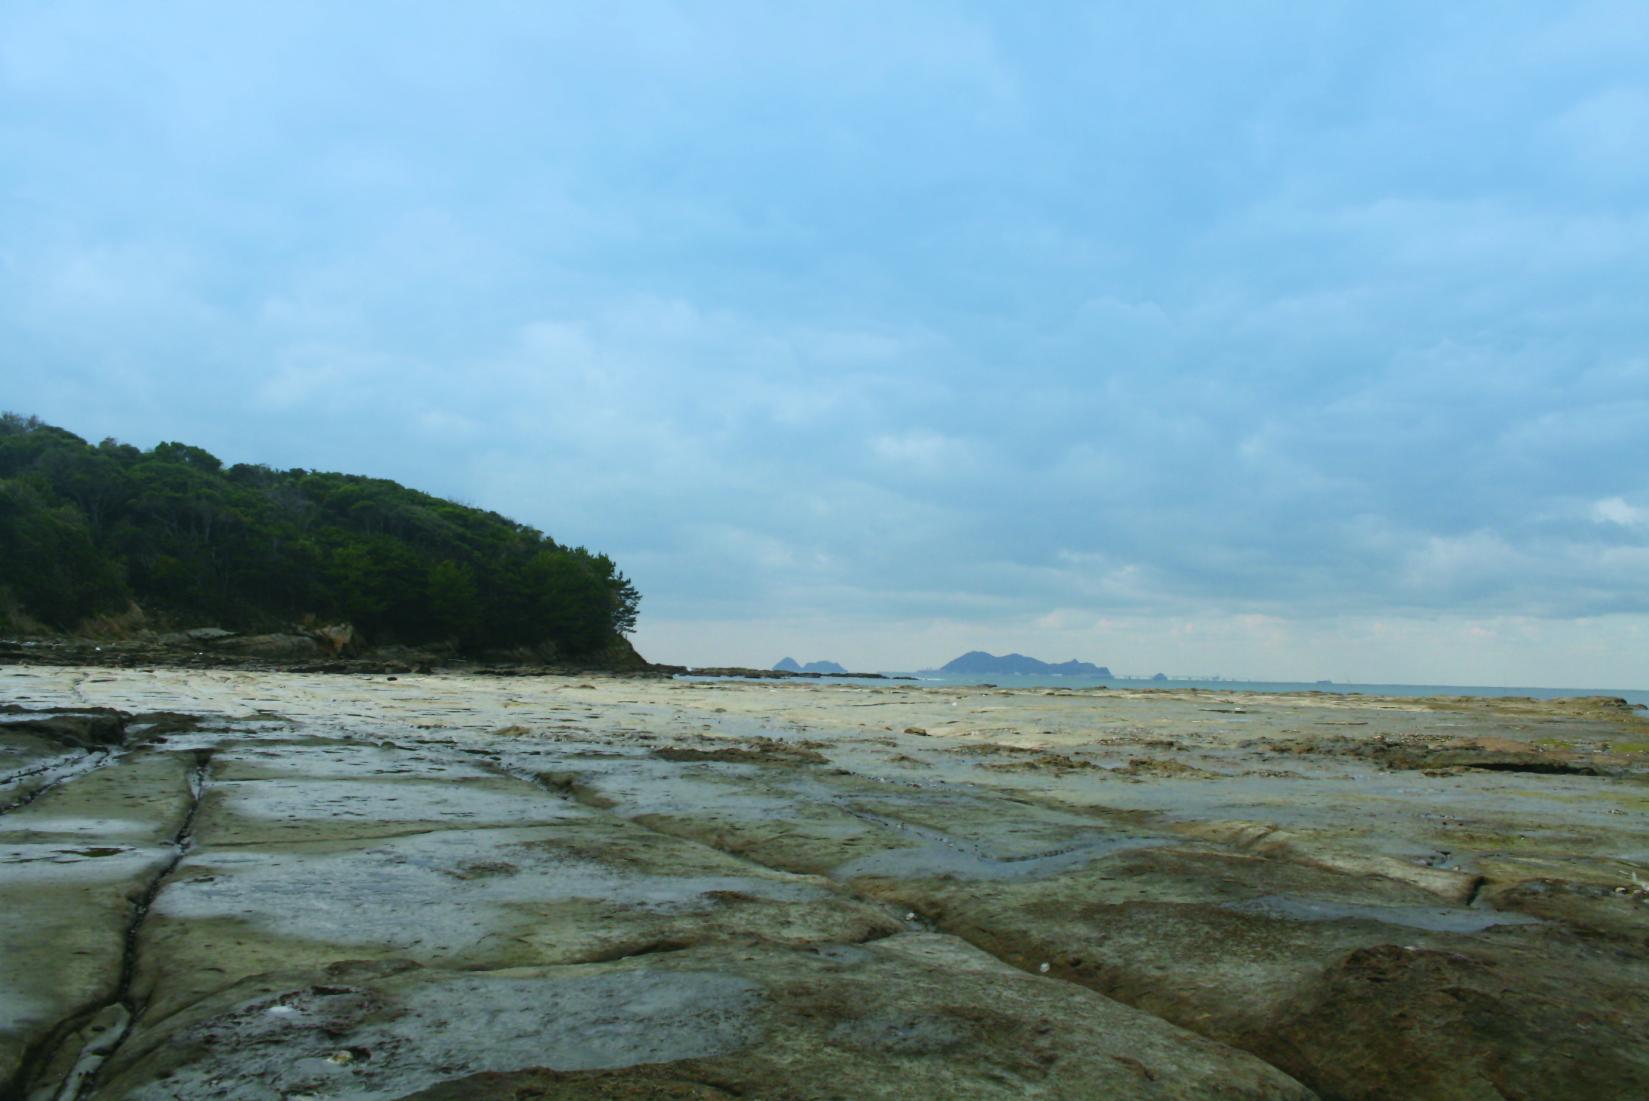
[94,933,1313,1101]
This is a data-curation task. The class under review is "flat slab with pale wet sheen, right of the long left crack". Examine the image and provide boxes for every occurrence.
[134,811,902,1012]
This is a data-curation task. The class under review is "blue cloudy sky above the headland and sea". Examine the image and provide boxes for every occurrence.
[0,0,1649,689]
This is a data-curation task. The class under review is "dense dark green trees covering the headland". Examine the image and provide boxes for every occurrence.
[0,414,638,654]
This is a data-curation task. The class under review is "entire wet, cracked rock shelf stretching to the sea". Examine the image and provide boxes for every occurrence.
[0,666,1649,1101]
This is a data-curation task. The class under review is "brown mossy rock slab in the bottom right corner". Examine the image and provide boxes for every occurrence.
[856,847,1649,1098]
